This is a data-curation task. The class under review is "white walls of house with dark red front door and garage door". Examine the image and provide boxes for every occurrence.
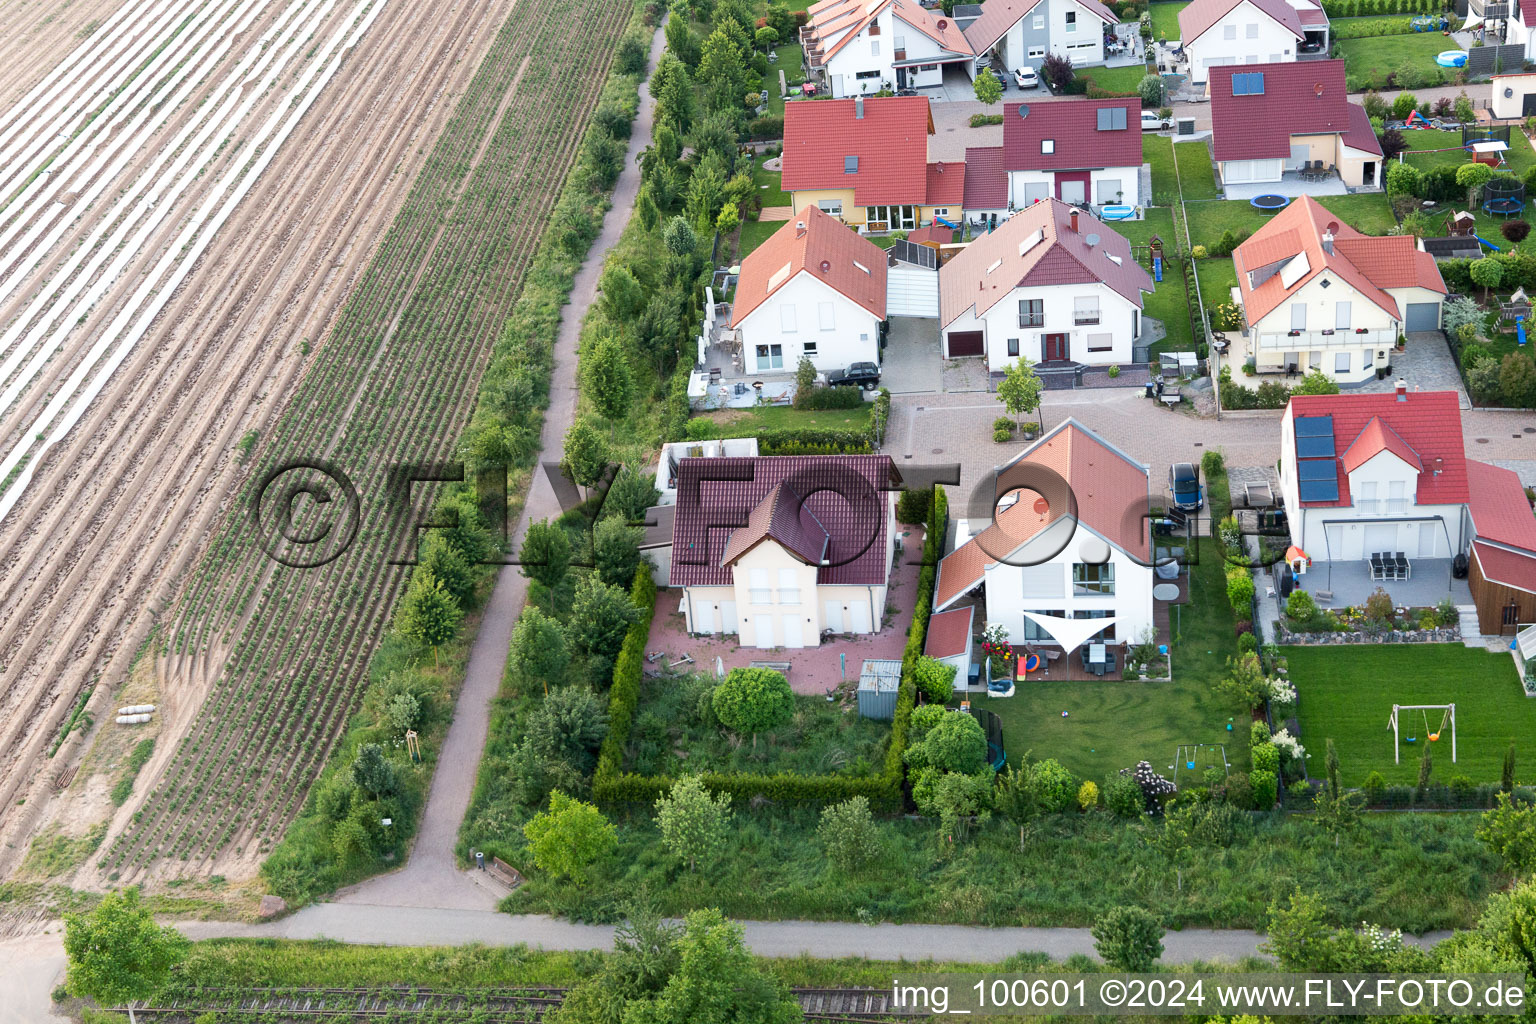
[964,284,1138,370]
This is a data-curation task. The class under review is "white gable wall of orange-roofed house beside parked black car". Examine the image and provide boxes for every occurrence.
[740,267,880,373]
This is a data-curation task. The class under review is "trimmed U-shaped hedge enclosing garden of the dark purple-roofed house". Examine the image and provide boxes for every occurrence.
[591,485,949,812]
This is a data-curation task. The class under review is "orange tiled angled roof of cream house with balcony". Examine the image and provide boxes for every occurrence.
[1212,198,1445,324]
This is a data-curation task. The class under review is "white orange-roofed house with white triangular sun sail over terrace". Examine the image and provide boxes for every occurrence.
[934,419,1154,652]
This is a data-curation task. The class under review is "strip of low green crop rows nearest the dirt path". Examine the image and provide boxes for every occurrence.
[91,0,631,878]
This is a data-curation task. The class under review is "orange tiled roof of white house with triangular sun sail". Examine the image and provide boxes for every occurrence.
[934,419,1150,611]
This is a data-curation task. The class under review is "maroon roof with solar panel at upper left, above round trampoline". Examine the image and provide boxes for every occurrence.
[1209,60,1381,163]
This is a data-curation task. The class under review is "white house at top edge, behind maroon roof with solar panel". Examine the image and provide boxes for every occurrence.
[1178,0,1329,84]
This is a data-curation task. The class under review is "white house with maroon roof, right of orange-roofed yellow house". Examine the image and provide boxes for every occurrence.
[995,100,1146,210]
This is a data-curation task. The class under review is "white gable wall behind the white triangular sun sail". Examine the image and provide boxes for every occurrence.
[986,519,1154,643]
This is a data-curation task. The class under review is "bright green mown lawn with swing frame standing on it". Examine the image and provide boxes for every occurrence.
[1284,643,1536,786]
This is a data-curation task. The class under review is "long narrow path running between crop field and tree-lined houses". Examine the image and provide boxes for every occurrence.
[336,16,665,910]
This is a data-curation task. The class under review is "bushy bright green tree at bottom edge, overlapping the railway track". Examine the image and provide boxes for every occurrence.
[624,909,803,1024]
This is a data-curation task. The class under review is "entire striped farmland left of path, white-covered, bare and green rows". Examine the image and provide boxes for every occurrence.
[0,0,628,870]
